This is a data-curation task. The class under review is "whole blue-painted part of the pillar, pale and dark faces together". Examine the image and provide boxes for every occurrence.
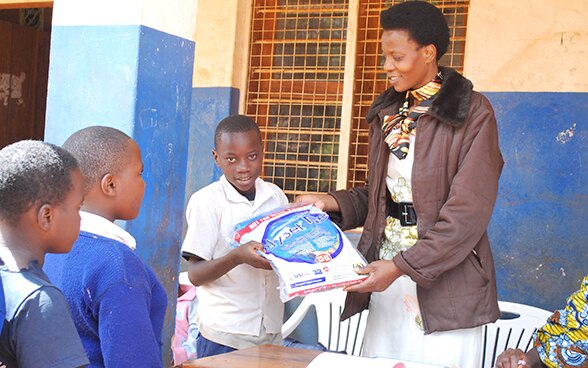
[45,26,194,364]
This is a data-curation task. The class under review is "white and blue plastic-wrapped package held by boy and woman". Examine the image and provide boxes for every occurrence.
[232,204,367,302]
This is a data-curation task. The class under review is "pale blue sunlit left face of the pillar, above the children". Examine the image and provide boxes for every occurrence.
[45,26,141,137]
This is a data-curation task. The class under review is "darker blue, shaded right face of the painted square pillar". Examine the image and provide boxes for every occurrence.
[127,26,194,354]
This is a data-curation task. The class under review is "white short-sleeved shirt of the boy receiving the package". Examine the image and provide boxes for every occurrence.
[182,176,288,348]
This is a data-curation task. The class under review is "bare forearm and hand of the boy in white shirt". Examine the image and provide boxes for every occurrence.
[188,241,271,286]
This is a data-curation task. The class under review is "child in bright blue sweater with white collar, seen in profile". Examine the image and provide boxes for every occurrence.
[45,126,167,367]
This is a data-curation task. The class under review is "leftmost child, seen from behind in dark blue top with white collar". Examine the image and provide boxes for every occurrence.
[0,141,88,367]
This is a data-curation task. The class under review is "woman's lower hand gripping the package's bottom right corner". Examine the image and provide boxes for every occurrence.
[344,260,403,293]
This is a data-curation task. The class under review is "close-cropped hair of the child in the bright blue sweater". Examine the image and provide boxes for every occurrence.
[63,126,131,192]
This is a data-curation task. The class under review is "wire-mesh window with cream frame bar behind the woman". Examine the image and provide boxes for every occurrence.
[245,0,469,199]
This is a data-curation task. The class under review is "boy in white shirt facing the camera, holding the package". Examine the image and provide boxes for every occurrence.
[182,115,288,358]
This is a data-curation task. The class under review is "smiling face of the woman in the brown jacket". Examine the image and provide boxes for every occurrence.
[382,29,438,92]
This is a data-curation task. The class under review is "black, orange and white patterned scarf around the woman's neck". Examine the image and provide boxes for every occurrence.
[382,72,443,160]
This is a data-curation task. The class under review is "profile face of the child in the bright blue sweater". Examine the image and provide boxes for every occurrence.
[115,139,145,220]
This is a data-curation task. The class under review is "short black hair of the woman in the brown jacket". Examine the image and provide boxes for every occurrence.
[380,1,449,60]
